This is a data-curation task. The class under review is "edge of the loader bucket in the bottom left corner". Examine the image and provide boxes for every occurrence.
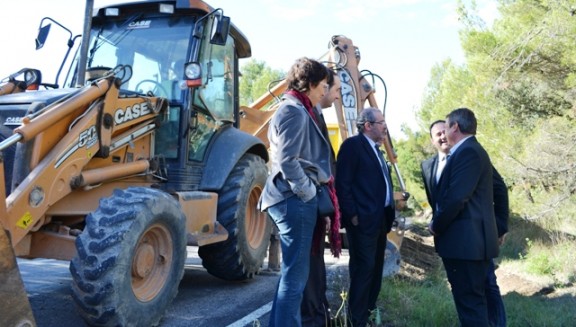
[0,225,36,327]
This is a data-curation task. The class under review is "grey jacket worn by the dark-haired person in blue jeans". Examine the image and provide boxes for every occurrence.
[259,95,331,211]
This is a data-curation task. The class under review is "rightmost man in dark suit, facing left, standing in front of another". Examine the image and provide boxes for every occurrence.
[429,108,498,327]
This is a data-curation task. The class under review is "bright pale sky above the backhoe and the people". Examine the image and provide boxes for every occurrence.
[0,0,497,138]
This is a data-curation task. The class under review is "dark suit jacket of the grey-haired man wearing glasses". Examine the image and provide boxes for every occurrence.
[336,134,395,232]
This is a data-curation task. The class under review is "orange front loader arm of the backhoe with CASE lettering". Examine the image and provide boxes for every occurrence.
[0,75,166,250]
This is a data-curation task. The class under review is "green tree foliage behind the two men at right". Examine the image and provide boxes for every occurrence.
[398,0,576,226]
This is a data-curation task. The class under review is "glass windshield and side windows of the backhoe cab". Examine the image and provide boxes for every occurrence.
[69,11,237,161]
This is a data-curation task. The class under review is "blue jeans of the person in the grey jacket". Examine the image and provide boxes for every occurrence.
[268,196,318,326]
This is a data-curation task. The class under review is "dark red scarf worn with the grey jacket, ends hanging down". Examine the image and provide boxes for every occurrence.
[286,90,342,258]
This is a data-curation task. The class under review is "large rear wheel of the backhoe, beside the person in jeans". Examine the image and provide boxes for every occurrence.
[198,154,272,280]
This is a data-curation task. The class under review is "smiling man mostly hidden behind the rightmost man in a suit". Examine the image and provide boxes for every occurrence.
[421,120,509,327]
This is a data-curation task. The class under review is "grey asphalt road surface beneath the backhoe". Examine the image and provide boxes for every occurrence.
[18,247,348,327]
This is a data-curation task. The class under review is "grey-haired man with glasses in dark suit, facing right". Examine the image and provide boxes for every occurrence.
[336,108,395,327]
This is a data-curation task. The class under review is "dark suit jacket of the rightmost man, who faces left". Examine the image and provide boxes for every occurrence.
[432,137,498,260]
